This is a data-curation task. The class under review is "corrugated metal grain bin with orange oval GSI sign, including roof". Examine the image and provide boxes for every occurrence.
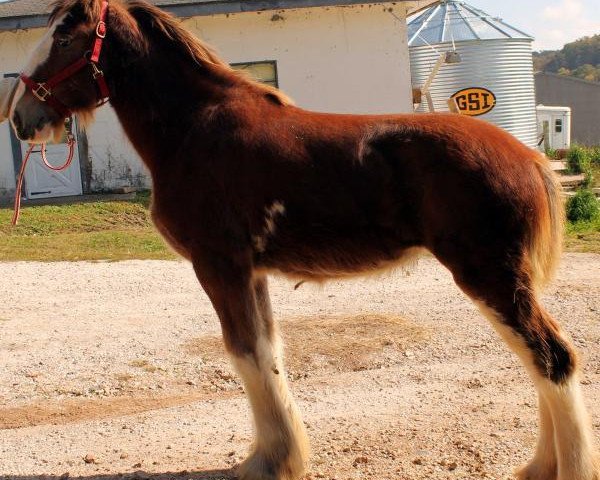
[408,0,537,147]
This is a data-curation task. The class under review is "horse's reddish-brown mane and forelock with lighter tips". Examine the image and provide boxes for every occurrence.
[50,0,293,105]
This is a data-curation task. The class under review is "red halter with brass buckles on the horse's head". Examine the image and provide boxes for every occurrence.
[21,0,110,118]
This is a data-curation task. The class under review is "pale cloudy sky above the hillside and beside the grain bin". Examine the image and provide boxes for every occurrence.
[466,0,600,50]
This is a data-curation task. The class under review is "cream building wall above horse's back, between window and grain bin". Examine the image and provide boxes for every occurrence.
[185,5,412,113]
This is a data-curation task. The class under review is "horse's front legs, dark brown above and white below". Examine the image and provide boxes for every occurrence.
[194,253,308,480]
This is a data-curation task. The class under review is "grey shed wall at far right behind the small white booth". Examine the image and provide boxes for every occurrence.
[535,73,600,145]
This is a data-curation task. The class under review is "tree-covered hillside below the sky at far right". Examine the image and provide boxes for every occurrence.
[533,34,600,82]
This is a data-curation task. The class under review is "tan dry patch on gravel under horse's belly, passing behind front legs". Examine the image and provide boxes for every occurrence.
[183,313,430,380]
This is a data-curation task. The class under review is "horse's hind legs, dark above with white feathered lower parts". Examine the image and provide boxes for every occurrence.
[451,260,600,480]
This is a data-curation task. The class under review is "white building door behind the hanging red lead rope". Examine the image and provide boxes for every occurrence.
[21,121,83,199]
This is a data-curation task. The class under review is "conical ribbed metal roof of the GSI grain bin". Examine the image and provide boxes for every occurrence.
[408,0,533,47]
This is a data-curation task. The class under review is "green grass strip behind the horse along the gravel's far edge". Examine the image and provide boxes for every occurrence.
[0,192,600,262]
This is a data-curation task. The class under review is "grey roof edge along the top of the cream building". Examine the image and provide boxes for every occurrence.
[0,0,435,32]
